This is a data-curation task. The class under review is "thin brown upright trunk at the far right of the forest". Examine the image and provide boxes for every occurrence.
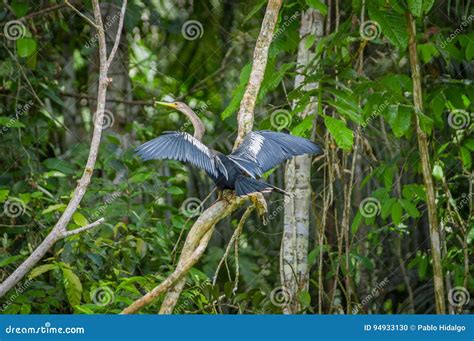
[407,13,446,314]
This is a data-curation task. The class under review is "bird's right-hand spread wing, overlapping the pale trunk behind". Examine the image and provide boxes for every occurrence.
[229,130,321,176]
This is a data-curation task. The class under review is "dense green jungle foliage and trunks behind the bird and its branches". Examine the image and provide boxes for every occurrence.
[0,0,474,314]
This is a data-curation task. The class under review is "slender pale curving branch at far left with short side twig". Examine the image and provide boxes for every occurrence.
[0,0,127,297]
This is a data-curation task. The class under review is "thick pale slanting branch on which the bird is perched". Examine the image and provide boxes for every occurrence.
[122,0,282,314]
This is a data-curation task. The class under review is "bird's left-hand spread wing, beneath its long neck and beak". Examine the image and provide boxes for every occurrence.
[135,131,217,176]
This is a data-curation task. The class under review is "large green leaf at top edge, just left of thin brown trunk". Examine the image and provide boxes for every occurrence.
[368,1,408,50]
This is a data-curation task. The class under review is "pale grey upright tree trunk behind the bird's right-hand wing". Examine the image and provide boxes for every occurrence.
[280,8,324,314]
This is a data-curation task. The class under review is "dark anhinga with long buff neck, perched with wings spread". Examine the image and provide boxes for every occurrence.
[135,102,321,196]
